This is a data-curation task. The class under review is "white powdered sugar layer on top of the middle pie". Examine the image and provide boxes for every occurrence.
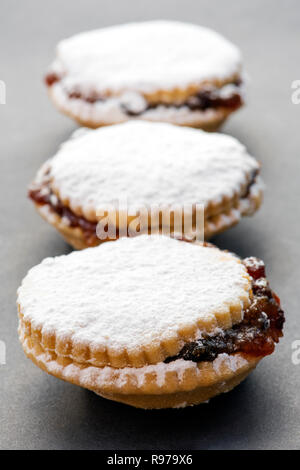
[50,121,259,215]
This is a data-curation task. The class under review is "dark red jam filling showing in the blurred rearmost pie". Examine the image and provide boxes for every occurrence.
[45,72,243,117]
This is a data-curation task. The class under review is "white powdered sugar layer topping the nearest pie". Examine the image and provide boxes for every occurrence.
[18,236,250,350]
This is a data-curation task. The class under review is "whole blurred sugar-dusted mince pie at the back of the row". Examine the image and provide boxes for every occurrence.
[46,21,242,131]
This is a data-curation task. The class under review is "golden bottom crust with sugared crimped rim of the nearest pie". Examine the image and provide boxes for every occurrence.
[19,326,262,408]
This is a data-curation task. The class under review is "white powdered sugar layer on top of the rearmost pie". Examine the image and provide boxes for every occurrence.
[52,21,241,94]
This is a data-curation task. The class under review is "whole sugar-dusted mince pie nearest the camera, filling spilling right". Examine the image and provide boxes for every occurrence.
[18,236,284,408]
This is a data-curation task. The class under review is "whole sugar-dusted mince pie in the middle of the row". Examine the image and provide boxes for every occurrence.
[30,122,263,249]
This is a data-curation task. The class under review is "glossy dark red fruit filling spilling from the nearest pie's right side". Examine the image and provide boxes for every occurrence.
[165,258,285,363]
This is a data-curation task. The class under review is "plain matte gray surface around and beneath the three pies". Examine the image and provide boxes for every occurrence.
[0,0,300,450]
